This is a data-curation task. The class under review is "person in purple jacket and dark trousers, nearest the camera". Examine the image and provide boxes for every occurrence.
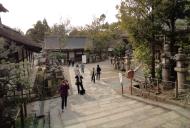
[59,80,69,112]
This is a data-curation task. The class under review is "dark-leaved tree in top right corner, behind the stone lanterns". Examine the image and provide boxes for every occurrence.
[155,0,190,55]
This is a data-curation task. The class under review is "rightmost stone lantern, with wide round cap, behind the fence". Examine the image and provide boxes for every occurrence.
[175,48,188,92]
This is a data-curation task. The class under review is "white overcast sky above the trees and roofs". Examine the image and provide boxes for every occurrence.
[0,0,121,32]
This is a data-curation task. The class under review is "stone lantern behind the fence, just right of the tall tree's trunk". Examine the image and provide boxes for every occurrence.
[161,44,171,81]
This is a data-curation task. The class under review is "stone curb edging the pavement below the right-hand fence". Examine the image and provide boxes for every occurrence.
[123,93,190,119]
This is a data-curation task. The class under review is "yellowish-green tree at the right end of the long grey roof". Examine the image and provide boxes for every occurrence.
[86,14,119,57]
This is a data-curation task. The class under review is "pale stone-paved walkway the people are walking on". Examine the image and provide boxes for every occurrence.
[30,61,190,128]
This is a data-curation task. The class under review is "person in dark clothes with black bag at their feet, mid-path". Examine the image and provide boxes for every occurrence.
[75,72,85,94]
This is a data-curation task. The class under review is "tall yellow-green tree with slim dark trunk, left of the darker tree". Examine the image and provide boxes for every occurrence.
[117,0,160,78]
